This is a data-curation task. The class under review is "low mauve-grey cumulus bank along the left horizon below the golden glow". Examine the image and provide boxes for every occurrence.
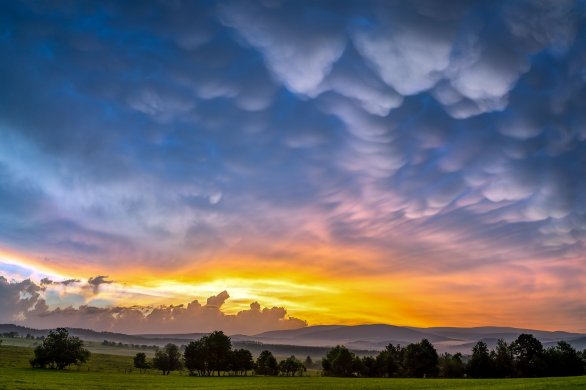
[0,276,307,334]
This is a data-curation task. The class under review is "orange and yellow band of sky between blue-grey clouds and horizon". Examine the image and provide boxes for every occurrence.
[0,247,581,331]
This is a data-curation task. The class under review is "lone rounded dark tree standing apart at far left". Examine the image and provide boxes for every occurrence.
[30,328,90,370]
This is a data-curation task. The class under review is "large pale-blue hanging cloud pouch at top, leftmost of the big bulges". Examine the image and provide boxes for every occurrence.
[221,2,345,95]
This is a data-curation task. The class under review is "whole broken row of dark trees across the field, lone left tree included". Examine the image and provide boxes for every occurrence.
[30,328,586,378]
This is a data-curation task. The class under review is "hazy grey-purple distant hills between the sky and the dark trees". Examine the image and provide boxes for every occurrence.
[0,324,586,357]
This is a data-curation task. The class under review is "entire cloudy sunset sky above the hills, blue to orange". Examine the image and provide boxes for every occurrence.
[0,0,586,334]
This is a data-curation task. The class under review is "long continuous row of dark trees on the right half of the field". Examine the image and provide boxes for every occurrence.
[322,334,586,378]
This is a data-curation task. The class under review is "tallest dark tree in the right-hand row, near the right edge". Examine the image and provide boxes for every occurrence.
[511,333,545,377]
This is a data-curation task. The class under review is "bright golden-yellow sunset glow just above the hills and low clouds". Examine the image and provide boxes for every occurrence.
[0,247,572,330]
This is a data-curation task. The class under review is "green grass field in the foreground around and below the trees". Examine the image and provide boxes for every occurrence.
[0,345,586,390]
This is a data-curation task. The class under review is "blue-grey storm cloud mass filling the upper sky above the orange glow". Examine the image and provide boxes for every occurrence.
[0,1,586,290]
